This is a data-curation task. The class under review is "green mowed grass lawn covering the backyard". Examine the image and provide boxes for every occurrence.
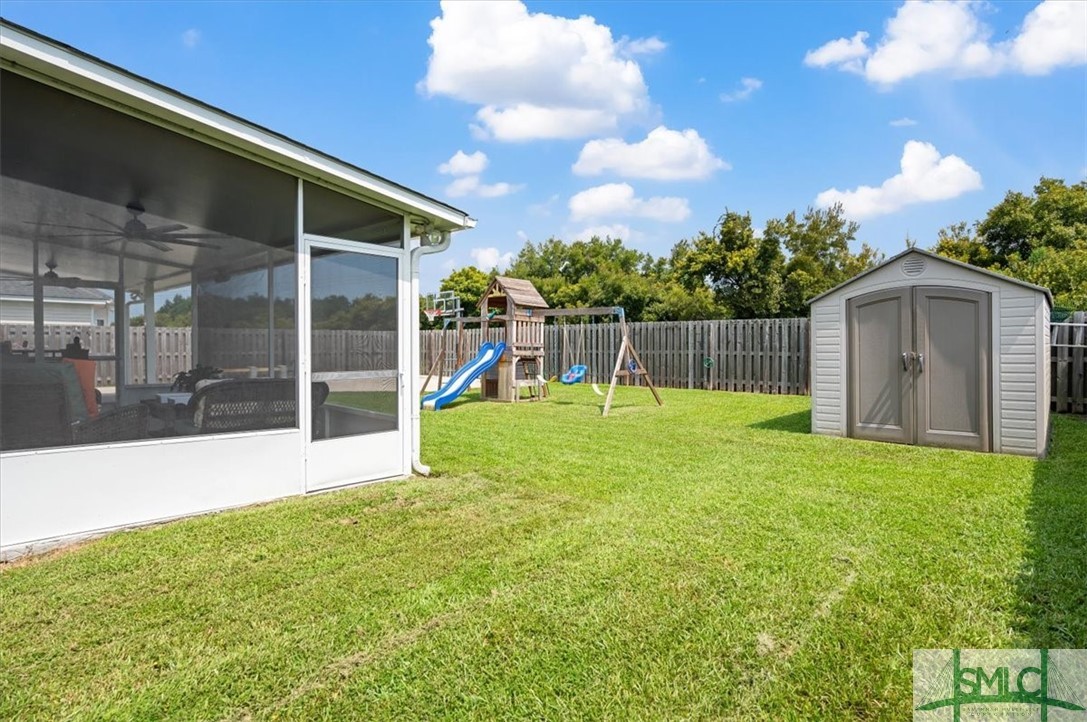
[0,384,1087,720]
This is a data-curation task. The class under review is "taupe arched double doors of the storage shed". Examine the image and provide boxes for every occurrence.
[847,286,990,451]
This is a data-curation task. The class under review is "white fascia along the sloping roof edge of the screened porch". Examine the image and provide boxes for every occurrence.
[0,18,476,231]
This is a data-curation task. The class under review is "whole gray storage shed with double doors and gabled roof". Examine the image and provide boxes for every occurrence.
[809,248,1052,457]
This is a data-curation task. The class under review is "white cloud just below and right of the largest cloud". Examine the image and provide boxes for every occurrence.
[573,125,729,181]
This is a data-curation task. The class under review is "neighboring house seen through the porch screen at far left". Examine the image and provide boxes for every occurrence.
[0,278,113,326]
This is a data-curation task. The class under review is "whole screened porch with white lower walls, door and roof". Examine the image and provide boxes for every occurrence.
[0,22,475,556]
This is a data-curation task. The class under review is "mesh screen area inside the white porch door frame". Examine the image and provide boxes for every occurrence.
[310,249,400,440]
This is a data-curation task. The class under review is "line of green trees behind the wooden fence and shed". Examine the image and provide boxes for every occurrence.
[430,177,1087,327]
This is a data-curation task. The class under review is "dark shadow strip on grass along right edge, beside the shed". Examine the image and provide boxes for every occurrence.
[1017,414,1087,648]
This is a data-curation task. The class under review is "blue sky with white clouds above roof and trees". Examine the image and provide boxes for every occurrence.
[2,0,1087,289]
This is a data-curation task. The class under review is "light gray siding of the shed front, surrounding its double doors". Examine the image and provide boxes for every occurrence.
[811,251,1050,456]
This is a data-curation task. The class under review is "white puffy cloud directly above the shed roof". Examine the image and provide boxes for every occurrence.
[815,140,982,221]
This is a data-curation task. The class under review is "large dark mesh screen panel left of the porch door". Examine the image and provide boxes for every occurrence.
[0,70,299,452]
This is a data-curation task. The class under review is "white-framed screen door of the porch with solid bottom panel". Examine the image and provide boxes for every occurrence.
[303,237,408,491]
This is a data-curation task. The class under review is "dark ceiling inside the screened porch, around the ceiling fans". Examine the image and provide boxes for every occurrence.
[0,71,400,289]
